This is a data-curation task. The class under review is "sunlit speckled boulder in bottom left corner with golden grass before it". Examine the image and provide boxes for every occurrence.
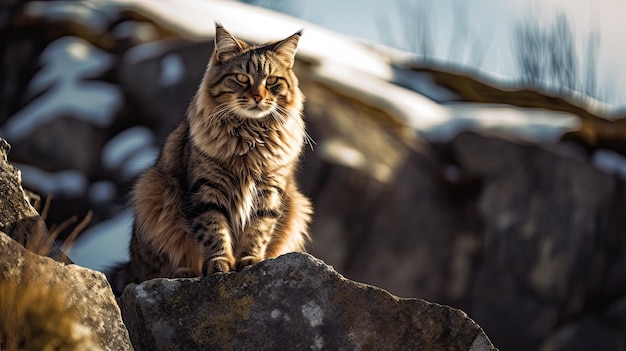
[0,233,132,351]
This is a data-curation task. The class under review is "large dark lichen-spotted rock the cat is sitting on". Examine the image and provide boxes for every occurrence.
[121,253,494,350]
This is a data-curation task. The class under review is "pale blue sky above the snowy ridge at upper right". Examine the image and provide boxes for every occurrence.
[290,0,626,105]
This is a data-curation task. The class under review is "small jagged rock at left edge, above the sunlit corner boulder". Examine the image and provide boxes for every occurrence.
[0,138,71,263]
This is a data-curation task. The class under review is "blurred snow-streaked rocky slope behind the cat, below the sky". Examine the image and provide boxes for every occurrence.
[0,0,626,350]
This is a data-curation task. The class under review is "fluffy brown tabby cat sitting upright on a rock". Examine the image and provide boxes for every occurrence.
[107,23,312,296]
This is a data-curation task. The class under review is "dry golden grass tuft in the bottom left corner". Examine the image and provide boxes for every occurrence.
[0,199,100,351]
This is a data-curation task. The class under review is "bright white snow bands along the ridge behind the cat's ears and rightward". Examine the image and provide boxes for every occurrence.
[105,0,578,141]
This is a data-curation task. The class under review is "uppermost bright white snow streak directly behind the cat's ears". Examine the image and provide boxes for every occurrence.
[111,0,392,79]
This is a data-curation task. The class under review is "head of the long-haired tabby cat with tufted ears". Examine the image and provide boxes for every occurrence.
[204,23,302,119]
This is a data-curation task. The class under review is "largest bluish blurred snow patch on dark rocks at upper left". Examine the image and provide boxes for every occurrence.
[0,37,122,142]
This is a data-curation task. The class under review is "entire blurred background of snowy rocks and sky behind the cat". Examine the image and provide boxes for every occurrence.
[0,0,626,350]
